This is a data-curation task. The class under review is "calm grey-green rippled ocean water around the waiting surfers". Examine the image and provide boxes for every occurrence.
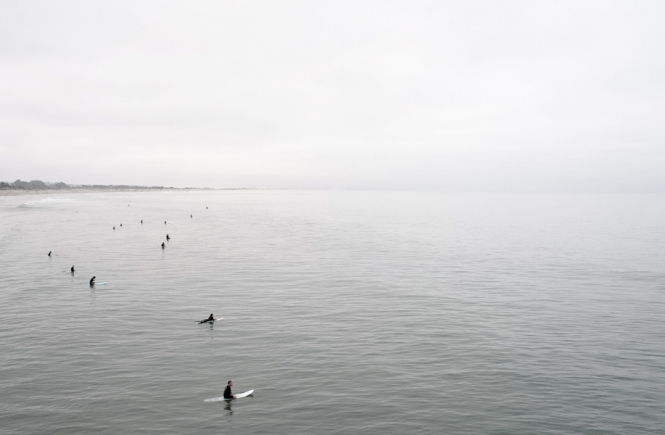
[0,191,665,435]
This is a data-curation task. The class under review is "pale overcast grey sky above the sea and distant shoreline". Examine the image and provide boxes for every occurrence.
[0,0,665,192]
